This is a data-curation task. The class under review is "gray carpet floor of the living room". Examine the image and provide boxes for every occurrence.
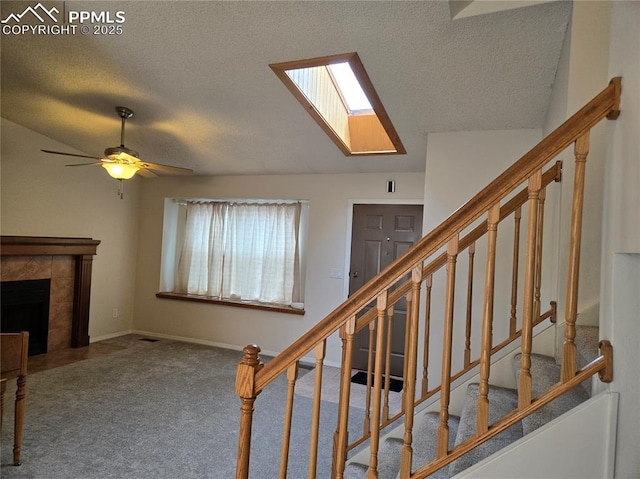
[0,336,364,479]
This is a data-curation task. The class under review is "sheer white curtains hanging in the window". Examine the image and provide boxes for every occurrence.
[176,202,300,305]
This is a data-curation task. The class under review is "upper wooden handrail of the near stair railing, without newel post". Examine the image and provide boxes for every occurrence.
[248,77,621,393]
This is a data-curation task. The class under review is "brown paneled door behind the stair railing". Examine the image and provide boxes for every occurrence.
[349,205,422,377]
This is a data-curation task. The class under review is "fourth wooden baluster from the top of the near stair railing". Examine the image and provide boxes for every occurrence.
[436,234,458,458]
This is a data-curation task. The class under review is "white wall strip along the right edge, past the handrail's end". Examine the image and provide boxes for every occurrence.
[600,2,640,478]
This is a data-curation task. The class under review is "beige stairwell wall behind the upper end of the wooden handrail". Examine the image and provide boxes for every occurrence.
[543,1,610,339]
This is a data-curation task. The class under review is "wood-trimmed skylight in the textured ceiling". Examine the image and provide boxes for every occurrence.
[269,53,406,155]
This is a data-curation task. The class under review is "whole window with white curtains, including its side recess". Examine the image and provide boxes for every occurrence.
[160,199,307,310]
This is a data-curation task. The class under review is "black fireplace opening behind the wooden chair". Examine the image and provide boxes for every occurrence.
[0,279,51,356]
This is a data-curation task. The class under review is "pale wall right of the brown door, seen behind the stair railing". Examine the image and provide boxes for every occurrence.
[418,130,553,386]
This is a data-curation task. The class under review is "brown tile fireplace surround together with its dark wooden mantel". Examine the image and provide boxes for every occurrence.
[0,236,100,352]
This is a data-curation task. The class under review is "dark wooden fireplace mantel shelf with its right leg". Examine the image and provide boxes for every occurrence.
[0,236,100,348]
